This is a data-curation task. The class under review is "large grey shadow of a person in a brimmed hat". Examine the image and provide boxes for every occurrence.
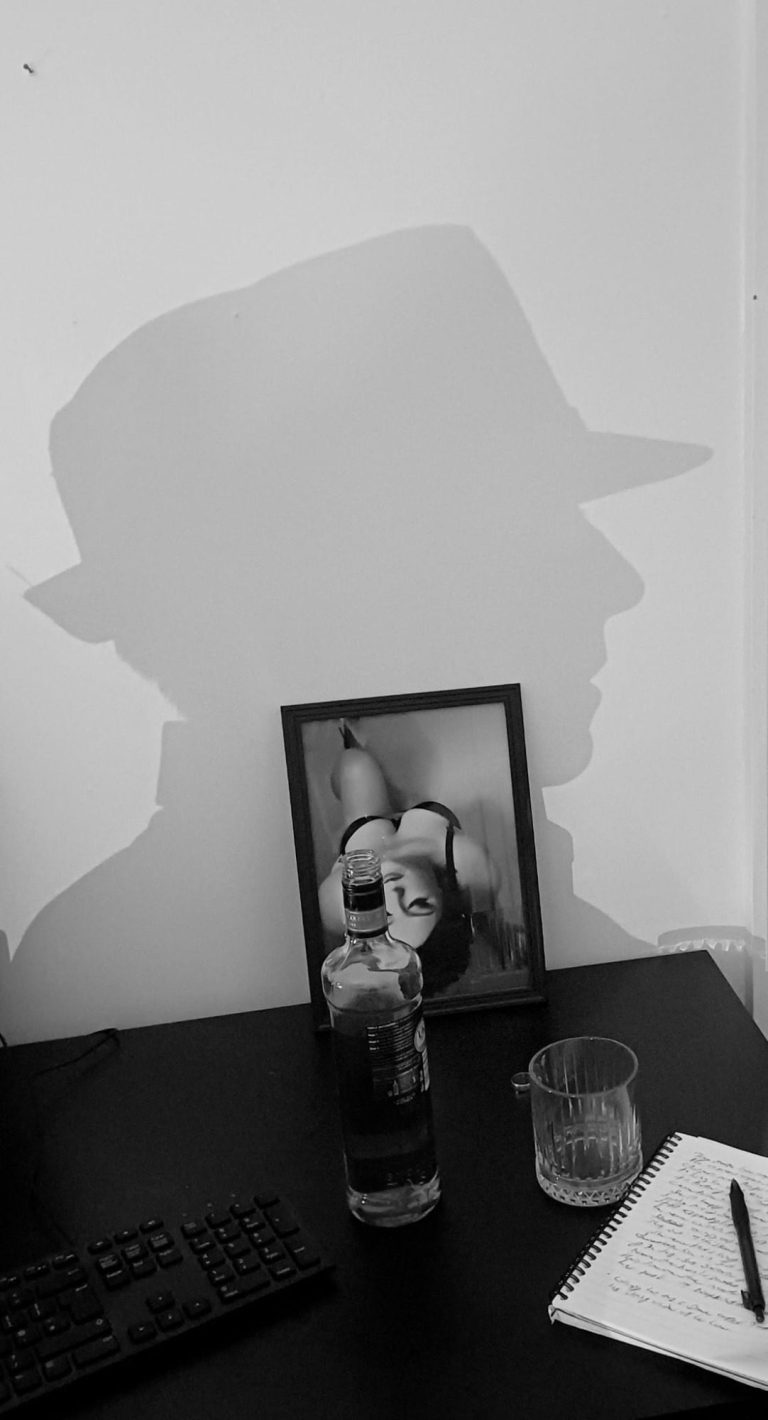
[4,226,708,1038]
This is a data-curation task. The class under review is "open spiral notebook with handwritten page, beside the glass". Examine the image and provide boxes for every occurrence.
[549,1133,768,1389]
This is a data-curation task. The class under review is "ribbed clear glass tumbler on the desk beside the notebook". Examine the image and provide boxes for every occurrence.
[528,1035,643,1207]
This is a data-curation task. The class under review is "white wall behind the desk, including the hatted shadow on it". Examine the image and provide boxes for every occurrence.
[0,0,762,1039]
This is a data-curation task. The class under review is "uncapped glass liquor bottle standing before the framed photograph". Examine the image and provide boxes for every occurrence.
[321,848,440,1227]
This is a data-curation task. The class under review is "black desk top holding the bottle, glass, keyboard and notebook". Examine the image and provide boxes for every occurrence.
[0,953,768,1420]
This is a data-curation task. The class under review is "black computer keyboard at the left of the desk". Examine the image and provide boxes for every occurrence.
[0,1189,332,1416]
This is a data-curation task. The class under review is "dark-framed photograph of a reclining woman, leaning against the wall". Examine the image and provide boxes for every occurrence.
[281,684,544,1030]
